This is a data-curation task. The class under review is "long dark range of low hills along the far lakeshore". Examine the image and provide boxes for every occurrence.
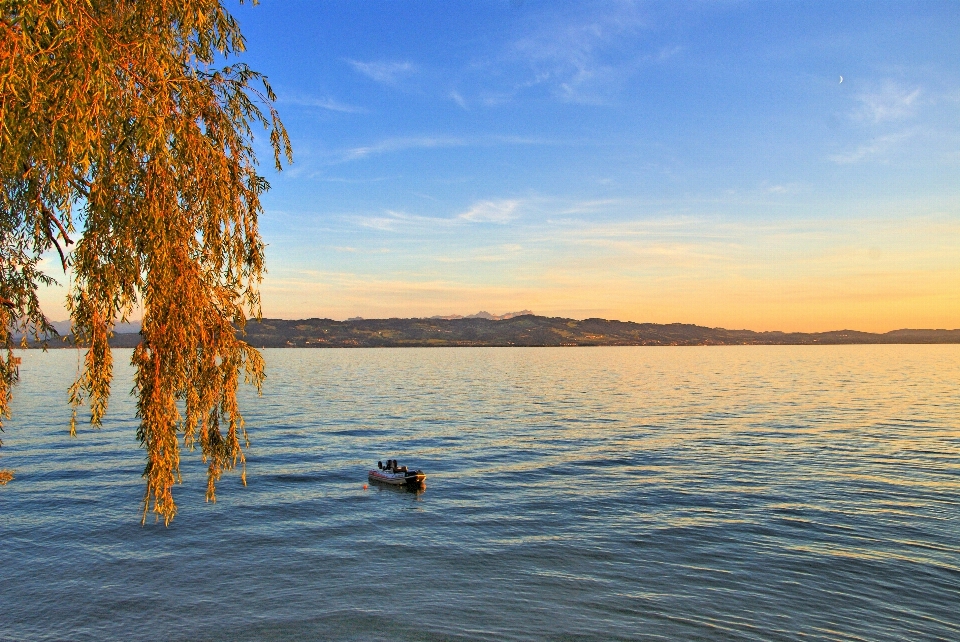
[22,314,960,348]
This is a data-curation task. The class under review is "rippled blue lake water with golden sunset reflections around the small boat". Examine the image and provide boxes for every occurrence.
[0,346,960,640]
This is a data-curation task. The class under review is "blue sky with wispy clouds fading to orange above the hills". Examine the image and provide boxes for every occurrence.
[41,0,960,332]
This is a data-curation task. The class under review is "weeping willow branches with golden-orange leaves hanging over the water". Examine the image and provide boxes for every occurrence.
[0,0,292,523]
